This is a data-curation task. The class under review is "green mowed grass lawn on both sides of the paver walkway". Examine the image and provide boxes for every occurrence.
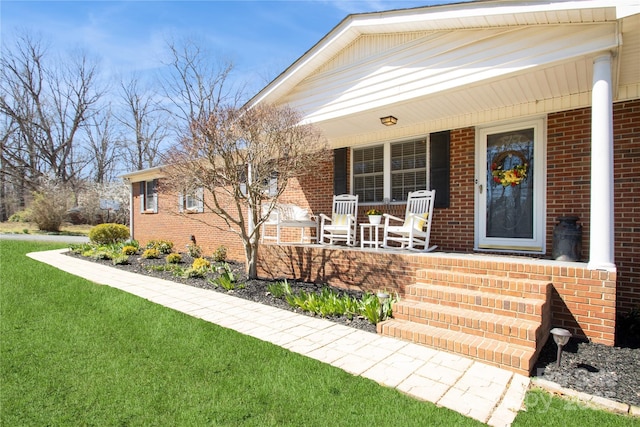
[0,240,638,427]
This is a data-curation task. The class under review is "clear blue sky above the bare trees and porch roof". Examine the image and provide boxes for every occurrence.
[0,0,460,94]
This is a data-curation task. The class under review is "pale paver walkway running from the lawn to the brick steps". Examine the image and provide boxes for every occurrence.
[28,249,529,426]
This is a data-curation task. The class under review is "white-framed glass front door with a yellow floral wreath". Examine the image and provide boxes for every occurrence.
[475,119,546,253]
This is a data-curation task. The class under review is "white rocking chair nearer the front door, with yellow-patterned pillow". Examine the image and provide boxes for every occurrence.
[382,190,437,252]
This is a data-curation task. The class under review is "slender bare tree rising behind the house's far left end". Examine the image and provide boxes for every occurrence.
[119,77,167,170]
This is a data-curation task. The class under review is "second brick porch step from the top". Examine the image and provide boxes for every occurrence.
[404,283,548,321]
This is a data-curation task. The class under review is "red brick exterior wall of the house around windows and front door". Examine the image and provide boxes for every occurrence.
[133,100,640,334]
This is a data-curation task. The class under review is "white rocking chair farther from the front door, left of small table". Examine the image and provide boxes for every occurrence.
[319,194,358,246]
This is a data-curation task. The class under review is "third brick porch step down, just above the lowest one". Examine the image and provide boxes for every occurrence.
[393,300,545,349]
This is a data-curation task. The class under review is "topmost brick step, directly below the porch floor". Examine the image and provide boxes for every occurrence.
[416,269,552,300]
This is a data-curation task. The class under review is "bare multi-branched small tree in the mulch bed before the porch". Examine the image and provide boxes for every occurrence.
[163,104,329,278]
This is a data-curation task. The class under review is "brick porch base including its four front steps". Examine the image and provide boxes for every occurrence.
[258,245,616,373]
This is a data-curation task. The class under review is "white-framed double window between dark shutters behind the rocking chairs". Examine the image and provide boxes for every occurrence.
[353,139,428,203]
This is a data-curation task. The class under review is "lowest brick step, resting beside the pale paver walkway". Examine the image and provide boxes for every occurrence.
[377,318,537,376]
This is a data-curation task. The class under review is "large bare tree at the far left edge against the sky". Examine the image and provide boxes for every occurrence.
[0,35,102,212]
